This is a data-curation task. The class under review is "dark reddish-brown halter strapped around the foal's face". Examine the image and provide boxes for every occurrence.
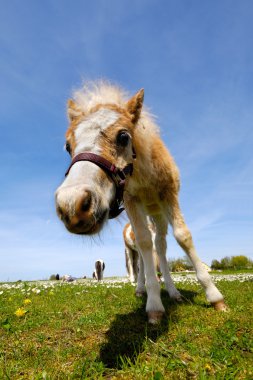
[65,152,133,219]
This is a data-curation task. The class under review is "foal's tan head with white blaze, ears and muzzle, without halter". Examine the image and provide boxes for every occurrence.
[55,85,144,235]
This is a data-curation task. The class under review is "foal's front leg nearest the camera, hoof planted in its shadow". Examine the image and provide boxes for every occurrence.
[125,200,165,324]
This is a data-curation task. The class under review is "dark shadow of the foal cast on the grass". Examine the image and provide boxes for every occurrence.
[98,290,197,369]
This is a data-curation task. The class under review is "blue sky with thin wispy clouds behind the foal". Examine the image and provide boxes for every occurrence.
[0,0,253,281]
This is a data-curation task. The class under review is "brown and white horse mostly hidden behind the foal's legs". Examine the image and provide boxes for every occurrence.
[123,221,163,286]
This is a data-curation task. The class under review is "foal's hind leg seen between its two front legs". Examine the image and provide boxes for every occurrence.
[152,215,182,302]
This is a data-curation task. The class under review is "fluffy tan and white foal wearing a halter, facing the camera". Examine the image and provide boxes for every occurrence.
[55,82,226,323]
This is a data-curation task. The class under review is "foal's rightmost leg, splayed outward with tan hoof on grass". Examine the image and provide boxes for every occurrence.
[169,199,227,310]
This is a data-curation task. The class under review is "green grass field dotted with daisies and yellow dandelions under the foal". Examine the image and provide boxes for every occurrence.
[0,273,253,380]
